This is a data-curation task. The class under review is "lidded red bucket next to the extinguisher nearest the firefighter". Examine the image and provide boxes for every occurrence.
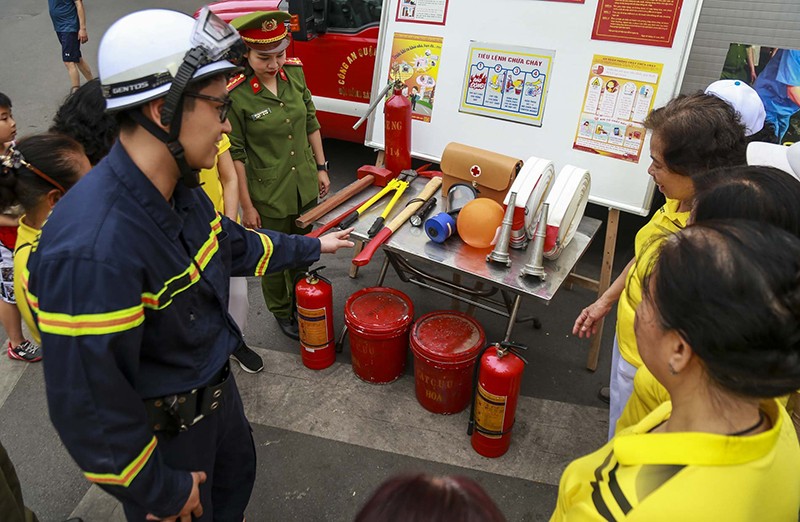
[344,287,414,384]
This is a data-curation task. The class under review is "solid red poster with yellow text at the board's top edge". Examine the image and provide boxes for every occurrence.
[592,0,683,47]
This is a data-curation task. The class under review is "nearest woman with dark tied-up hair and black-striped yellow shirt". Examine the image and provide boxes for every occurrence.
[551,220,800,522]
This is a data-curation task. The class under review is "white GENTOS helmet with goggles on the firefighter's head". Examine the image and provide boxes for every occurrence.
[98,8,240,111]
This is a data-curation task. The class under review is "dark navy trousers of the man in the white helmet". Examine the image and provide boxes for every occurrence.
[123,375,256,522]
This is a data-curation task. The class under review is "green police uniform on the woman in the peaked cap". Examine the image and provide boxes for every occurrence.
[228,59,320,317]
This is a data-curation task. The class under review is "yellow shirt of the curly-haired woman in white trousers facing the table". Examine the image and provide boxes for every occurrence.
[617,199,689,368]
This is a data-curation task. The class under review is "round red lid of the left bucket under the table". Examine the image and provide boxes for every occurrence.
[344,286,414,333]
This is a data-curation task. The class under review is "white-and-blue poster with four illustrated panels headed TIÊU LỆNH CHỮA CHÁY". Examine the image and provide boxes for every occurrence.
[459,42,555,127]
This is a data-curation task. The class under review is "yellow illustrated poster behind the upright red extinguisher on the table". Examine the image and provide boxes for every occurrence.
[389,33,442,122]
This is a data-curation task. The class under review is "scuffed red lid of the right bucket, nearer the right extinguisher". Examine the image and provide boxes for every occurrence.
[411,311,486,364]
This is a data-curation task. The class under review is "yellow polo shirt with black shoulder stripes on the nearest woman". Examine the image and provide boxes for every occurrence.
[550,400,800,522]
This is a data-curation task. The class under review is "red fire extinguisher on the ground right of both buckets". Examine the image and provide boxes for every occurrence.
[467,342,528,452]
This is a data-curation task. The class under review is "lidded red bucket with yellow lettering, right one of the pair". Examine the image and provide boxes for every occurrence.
[411,311,486,414]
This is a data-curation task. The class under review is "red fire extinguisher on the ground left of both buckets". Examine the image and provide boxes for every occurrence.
[295,266,336,370]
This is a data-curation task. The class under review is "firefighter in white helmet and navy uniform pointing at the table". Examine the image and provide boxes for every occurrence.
[27,9,352,521]
